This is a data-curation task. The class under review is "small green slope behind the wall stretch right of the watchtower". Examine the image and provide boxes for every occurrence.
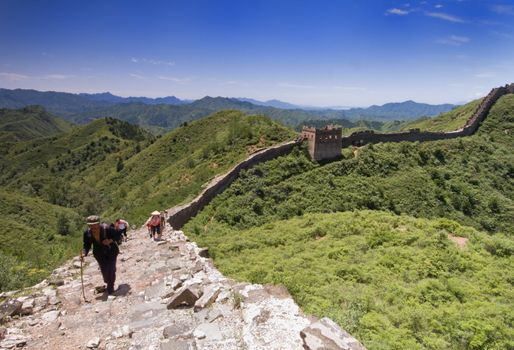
[402,99,482,131]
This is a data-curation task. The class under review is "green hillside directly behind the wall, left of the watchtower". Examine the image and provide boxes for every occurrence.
[98,111,294,222]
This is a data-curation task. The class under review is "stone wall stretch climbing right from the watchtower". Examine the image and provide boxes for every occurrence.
[341,83,514,148]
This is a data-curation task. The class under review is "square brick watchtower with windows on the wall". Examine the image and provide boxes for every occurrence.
[302,125,343,161]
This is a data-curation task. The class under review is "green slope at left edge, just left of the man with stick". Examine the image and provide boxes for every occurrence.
[0,190,83,290]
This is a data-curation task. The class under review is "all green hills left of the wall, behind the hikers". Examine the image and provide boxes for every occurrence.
[0,110,295,290]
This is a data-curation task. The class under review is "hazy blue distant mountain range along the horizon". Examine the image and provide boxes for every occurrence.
[0,89,455,133]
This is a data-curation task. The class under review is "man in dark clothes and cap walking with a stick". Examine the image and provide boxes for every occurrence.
[80,215,120,294]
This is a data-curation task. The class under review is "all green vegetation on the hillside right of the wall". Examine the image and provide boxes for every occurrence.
[185,95,514,349]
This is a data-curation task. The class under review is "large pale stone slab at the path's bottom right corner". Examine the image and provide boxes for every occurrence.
[300,317,366,350]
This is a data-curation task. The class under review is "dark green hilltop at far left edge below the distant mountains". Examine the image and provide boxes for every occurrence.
[0,106,72,143]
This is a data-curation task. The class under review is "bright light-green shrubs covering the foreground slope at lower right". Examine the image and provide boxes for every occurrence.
[187,211,514,350]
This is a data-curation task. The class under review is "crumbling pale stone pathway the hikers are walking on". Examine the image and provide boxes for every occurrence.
[0,228,364,350]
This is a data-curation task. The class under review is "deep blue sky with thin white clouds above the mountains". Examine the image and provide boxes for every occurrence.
[0,0,514,106]
